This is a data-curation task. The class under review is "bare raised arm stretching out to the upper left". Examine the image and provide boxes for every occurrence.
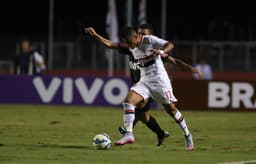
[84,27,119,49]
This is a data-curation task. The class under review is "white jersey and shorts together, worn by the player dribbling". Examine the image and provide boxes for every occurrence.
[130,35,177,104]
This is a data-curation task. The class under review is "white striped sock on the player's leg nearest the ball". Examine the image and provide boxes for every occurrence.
[123,103,135,132]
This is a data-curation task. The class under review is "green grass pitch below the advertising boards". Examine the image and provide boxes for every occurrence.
[0,105,256,164]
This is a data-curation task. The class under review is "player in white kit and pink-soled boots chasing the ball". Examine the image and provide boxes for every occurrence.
[115,27,194,150]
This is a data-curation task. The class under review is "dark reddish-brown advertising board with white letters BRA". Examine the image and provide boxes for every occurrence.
[173,80,256,111]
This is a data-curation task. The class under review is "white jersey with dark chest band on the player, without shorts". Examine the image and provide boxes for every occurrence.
[130,35,169,81]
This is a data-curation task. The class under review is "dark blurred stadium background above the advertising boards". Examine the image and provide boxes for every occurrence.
[0,0,256,73]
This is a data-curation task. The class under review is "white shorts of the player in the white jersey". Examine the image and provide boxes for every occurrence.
[131,76,178,104]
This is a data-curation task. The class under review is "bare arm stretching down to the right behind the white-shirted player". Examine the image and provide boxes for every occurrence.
[167,56,202,77]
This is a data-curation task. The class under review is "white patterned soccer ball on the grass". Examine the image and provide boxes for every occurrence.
[93,133,111,150]
